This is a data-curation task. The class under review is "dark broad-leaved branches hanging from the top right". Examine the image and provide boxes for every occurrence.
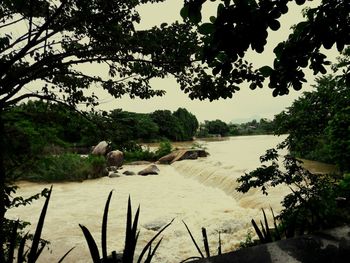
[181,0,350,96]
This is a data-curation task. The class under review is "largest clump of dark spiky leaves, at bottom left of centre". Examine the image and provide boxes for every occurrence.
[79,191,173,263]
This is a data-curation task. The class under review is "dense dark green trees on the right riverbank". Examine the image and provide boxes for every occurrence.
[274,75,350,171]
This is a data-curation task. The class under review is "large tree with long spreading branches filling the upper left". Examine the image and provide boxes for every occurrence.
[0,0,216,262]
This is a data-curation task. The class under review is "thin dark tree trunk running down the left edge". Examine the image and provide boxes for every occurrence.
[0,108,6,262]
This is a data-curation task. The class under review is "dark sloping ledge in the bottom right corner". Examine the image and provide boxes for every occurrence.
[191,226,350,263]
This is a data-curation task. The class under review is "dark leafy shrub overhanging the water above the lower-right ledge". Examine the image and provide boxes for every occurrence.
[237,149,343,240]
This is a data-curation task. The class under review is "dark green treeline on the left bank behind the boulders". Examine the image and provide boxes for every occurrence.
[4,101,198,155]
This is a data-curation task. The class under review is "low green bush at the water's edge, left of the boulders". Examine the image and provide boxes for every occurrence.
[20,153,105,182]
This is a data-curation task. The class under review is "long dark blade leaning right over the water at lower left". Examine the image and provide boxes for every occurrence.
[28,185,52,263]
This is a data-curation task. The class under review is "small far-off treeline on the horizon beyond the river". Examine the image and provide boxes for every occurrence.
[197,119,274,137]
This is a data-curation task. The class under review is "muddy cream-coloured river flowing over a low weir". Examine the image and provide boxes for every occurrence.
[8,135,332,263]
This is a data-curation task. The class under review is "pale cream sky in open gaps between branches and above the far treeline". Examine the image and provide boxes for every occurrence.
[90,0,328,123]
